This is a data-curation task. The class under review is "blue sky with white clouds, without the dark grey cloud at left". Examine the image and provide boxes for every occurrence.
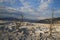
[0,0,60,20]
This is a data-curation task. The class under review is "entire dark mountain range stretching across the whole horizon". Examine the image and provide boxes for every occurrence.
[0,17,60,23]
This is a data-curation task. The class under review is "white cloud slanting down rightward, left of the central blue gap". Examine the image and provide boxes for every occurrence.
[18,0,36,15]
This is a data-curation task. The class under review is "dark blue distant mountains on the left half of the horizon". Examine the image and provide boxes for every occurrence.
[0,17,38,22]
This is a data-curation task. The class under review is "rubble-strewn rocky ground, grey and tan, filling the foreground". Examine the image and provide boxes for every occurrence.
[0,21,60,40]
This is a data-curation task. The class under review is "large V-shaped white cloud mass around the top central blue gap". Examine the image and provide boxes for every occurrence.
[19,0,51,19]
